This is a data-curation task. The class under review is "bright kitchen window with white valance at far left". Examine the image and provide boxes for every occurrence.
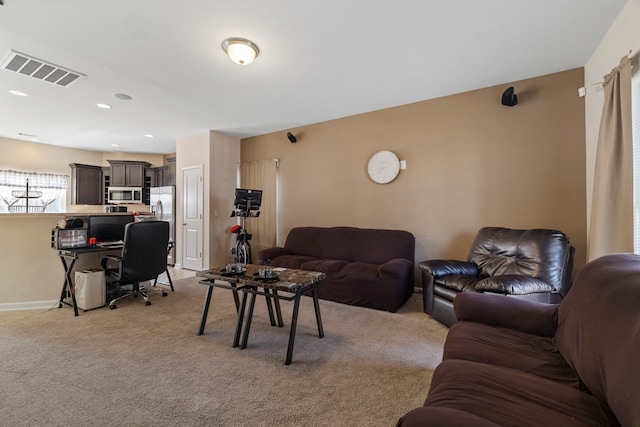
[0,170,69,213]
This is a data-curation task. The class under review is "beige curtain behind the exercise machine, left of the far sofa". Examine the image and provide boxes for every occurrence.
[240,159,278,256]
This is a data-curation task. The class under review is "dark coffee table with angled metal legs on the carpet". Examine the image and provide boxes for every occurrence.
[196,264,326,365]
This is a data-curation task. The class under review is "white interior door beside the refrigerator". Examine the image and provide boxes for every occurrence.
[182,166,204,270]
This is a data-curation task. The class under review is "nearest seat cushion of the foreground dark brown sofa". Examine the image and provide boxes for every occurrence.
[425,359,616,427]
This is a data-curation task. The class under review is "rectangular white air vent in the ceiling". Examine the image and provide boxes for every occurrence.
[0,50,86,87]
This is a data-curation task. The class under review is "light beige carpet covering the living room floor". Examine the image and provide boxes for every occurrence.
[0,278,447,427]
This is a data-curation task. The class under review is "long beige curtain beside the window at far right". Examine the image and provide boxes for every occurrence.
[587,56,633,261]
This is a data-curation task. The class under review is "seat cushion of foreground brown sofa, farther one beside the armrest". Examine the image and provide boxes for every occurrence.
[443,321,580,388]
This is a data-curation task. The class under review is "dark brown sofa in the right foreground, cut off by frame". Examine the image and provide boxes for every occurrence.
[397,254,640,427]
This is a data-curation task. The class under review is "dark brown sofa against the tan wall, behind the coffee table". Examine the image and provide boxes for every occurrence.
[258,227,415,312]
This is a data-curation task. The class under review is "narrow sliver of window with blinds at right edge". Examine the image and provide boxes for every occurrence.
[631,59,640,254]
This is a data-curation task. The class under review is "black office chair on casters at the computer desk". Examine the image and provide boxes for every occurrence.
[101,221,169,309]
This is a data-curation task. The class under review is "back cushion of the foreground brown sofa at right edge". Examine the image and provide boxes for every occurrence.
[556,254,640,426]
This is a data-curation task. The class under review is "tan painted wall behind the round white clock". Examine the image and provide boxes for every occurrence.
[241,68,586,274]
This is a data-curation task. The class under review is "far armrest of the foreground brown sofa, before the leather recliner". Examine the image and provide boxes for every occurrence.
[453,292,558,337]
